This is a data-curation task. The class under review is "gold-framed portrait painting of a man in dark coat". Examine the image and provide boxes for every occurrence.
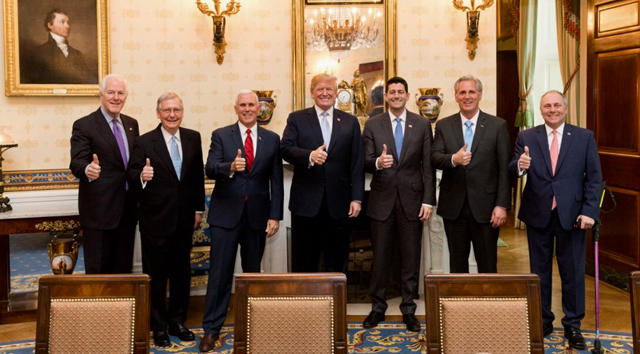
[2,0,110,96]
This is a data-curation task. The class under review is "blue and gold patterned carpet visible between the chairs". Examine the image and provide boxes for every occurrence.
[0,322,633,354]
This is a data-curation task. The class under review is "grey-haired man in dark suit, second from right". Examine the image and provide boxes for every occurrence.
[431,75,511,273]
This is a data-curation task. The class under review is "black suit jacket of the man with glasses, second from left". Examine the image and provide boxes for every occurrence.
[129,124,204,236]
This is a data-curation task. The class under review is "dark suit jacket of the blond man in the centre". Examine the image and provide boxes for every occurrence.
[280,107,364,218]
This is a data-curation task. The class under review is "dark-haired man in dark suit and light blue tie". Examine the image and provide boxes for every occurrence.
[363,77,436,332]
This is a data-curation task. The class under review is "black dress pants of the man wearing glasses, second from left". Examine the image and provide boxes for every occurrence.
[140,224,193,331]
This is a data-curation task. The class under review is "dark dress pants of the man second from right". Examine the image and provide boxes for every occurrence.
[443,198,500,273]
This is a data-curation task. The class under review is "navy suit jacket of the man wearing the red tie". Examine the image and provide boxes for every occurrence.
[206,123,284,230]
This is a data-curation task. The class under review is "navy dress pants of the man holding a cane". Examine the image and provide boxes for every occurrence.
[527,208,587,328]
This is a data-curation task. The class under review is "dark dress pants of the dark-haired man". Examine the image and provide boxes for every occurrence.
[370,196,422,314]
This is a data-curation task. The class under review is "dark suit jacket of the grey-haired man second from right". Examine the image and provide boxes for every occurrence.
[431,111,511,223]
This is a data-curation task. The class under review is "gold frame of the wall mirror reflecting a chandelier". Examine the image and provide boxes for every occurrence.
[292,0,398,110]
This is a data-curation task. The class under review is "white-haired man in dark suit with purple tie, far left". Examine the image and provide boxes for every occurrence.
[69,74,139,274]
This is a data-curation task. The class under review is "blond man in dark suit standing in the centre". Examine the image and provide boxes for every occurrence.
[281,74,364,272]
